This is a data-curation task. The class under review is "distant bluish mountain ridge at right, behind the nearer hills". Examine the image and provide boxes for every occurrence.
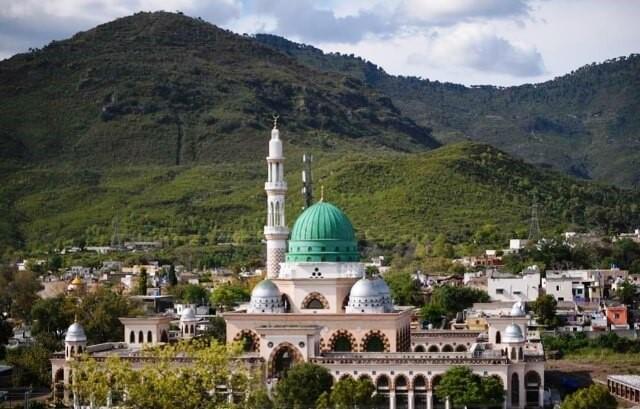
[255,34,640,187]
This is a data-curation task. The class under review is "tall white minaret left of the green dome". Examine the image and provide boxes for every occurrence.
[264,116,289,278]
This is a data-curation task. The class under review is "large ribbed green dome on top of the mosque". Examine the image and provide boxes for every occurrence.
[287,202,359,262]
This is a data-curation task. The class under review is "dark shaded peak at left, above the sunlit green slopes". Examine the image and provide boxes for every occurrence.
[0,12,439,168]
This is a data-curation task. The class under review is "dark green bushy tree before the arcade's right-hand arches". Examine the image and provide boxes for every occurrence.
[436,366,504,406]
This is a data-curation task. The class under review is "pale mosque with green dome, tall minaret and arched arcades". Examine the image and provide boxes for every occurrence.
[51,124,544,409]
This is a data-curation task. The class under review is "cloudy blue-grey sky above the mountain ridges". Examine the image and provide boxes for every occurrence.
[0,0,640,86]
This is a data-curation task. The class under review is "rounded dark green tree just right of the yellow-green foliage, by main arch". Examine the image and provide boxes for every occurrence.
[275,362,333,409]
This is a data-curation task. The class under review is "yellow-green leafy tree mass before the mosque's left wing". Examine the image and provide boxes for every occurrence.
[73,341,253,409]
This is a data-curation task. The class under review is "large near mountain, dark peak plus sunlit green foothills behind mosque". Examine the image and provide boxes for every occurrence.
[0,13,640,254]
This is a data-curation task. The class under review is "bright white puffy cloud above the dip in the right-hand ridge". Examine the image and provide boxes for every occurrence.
[418,24,545,77]
